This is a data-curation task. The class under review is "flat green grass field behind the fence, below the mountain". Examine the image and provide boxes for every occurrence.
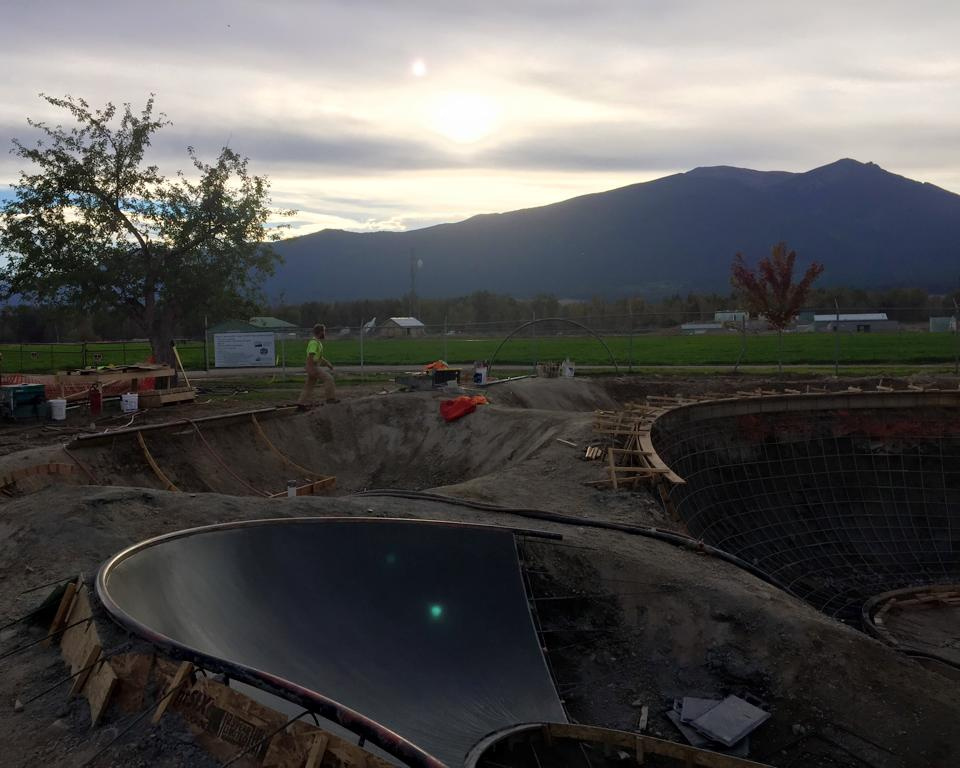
[0,332,957,373]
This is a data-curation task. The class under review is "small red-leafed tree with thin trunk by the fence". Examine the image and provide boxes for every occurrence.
[730,242,823,372]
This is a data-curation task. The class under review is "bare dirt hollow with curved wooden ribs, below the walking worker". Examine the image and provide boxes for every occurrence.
[58,393,589,495]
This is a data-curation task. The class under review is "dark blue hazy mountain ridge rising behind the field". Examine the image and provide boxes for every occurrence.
[265,159,960,302]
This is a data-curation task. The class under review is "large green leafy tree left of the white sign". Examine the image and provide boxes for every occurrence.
[0,96,292,360]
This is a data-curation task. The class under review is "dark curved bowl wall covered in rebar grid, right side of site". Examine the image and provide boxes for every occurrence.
[652,396,960,623]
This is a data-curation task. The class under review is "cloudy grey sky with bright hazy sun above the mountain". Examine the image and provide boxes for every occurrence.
[0,0,960,234]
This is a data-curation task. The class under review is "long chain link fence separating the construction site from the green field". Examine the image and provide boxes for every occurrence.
[0,307,960,374]
